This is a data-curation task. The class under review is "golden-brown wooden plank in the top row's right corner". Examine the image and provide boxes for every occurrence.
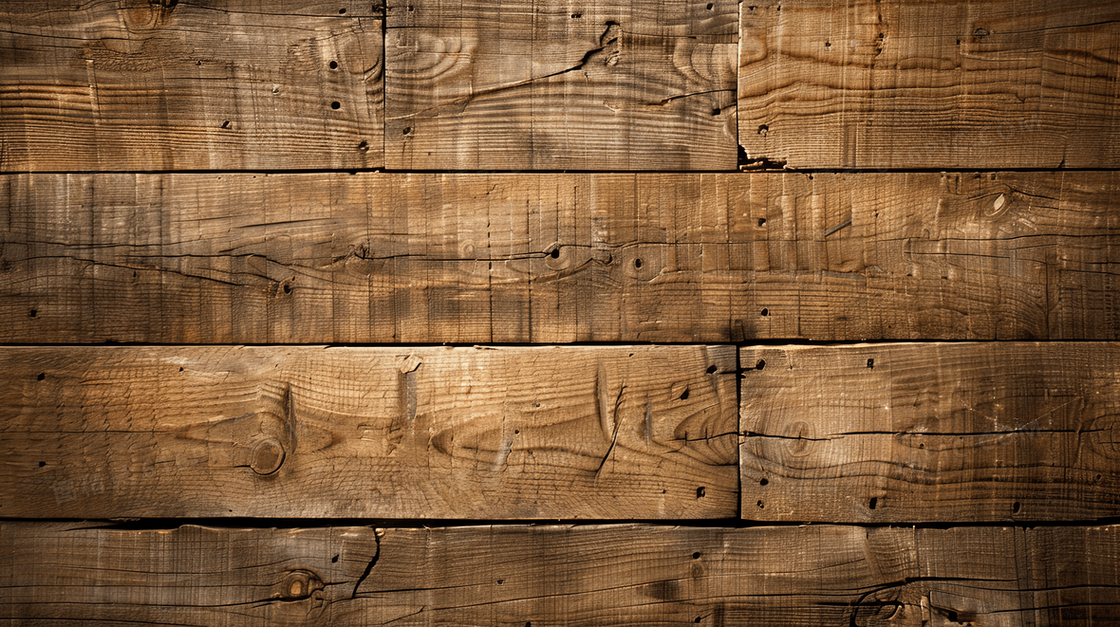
[738,0,1120,169]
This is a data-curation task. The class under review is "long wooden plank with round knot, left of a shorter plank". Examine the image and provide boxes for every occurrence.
[0,346,738,520]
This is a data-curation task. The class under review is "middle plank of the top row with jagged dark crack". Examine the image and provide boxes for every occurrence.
[385,0,738,170]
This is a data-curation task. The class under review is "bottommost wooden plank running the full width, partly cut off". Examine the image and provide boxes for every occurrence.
[8,522,1120,627]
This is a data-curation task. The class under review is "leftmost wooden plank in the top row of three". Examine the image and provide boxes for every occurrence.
[0,0,384,172]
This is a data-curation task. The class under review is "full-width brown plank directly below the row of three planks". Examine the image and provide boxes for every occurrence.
[0,172,1120,344]
